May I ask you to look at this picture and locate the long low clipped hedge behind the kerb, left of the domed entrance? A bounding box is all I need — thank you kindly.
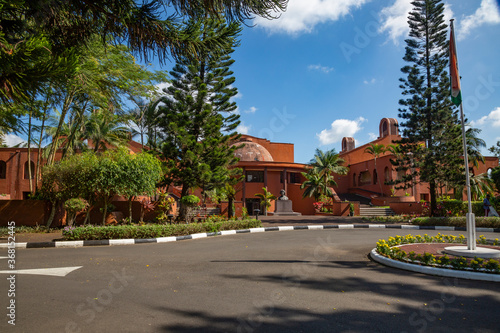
[63,219,262,240]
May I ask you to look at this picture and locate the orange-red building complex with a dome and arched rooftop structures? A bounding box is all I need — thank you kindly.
[0,118,498,215]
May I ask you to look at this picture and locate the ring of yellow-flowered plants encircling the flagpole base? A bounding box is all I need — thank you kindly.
[376,234,500,274]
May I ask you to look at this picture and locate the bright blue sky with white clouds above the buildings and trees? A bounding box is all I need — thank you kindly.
[7,0,500,163]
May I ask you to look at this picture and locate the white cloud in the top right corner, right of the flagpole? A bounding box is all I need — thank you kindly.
[457,0,500,39]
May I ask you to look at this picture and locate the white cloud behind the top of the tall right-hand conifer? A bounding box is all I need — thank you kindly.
[379,0,453,45]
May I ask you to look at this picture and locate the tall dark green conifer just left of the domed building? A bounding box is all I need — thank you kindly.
[158,19,241,217]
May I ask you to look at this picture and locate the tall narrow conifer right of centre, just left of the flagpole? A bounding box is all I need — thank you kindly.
[398,0,463,214]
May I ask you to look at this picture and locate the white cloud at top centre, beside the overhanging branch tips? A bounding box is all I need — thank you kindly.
[255,0,369,35]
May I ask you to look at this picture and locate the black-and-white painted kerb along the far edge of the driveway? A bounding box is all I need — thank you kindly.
[0,224,500,249]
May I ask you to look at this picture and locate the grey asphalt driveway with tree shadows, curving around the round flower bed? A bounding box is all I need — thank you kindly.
[0,229,500,332]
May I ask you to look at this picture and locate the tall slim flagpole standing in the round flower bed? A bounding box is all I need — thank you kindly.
[450,19,476,251]
